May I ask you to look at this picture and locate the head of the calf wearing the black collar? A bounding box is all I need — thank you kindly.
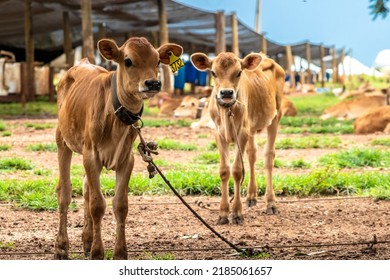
[98,37,183,98]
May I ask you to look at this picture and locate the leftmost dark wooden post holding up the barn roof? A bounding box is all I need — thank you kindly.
[22,0,35,102]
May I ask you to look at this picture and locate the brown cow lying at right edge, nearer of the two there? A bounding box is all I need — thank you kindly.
[354,106,390,134]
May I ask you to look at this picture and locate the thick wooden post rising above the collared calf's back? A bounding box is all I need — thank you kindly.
[81,0,95,64]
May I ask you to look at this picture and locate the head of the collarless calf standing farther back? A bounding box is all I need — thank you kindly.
[191,52,262,107]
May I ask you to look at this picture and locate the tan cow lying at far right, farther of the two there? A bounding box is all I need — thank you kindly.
[321,89,389,120]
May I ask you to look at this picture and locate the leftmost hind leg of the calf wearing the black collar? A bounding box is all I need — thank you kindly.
[54,129,72,260]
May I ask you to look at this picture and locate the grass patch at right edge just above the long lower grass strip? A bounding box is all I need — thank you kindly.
[319,148,390,168]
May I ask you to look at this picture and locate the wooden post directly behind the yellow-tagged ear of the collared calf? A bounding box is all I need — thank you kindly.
[157,0,173,93]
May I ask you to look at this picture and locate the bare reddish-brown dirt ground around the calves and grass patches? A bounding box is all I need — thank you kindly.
[0,119,390,260]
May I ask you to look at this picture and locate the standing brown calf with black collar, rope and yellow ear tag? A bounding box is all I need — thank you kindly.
[55,38,182,259]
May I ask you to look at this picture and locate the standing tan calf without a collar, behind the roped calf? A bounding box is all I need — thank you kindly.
[191,52,285,224]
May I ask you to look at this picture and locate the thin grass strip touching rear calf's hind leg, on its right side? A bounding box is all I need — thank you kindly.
[275,136,341,149]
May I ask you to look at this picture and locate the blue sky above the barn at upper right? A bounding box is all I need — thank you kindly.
[176,0,390,67]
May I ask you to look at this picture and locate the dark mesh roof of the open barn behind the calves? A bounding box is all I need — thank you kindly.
[0,0,336,62]
